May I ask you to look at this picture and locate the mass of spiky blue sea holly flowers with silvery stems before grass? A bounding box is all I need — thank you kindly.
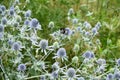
[0,0,120,80]
